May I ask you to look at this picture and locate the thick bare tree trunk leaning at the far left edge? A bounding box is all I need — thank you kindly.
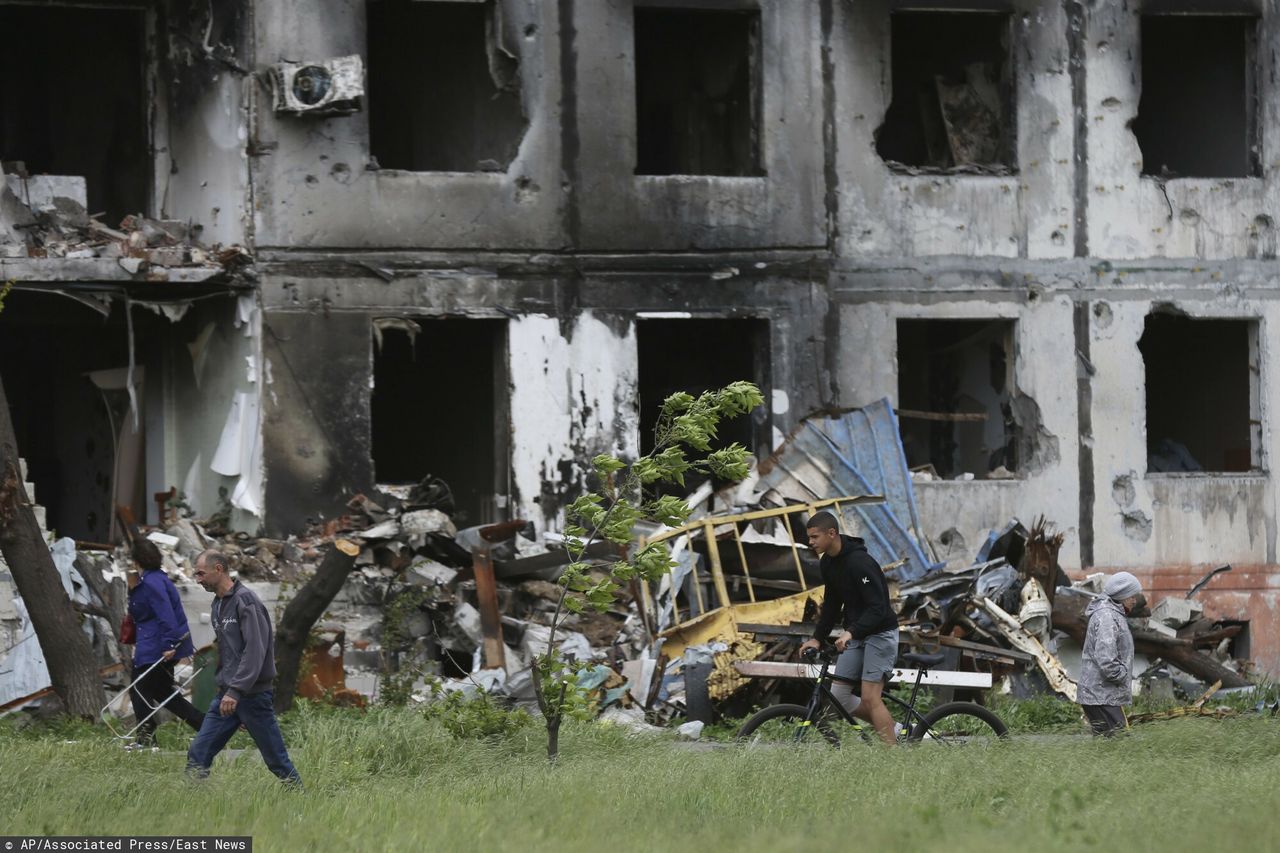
[0,382,106,720]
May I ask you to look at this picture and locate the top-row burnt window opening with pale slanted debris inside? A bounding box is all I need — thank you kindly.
[876,12,1016,173]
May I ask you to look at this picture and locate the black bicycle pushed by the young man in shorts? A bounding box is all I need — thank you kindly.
[737,644,1009,747]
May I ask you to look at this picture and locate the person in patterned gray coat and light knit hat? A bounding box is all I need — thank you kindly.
[1076,571,1142,738]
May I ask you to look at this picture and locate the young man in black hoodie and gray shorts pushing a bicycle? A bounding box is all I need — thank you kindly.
[800,510,897,744]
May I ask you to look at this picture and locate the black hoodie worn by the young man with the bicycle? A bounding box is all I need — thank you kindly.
[813,534,897,640]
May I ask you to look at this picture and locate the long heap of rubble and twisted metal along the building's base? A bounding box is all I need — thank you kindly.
[0,401,1251,727]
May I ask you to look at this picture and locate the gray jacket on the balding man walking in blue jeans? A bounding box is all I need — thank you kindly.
[212,580,275,699]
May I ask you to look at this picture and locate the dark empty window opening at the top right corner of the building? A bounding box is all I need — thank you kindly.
[1133,15,1262,178]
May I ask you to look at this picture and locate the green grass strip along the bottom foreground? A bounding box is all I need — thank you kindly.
[0,708,1280,853]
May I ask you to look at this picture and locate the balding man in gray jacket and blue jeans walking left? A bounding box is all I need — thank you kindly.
[187,551,302,786]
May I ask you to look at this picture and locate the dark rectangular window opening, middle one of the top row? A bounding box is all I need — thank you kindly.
[635,6,763,177]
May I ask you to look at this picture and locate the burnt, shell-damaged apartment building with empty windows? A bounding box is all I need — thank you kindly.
[0,0,1280,672]
